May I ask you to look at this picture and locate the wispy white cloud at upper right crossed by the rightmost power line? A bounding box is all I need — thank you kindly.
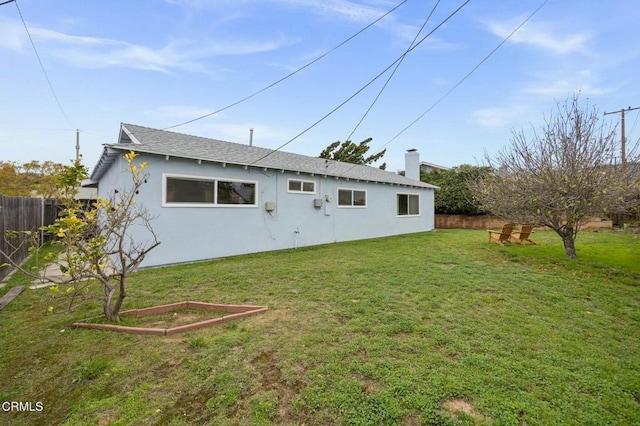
[485,17,590,55]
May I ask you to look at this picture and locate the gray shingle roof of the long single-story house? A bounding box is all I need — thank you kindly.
[91,123,437,189]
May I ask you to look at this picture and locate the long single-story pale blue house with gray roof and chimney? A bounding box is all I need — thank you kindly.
[91,124,437,267]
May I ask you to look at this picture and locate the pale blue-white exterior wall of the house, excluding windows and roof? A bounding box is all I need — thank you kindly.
[98,154,434,267]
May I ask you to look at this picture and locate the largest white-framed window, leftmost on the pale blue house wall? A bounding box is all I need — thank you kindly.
[164,176,257,206]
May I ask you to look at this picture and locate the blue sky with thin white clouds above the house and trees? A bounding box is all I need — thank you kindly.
[0,0,640,171]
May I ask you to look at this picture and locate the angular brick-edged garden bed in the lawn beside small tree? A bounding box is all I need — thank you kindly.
[72,302,268,336]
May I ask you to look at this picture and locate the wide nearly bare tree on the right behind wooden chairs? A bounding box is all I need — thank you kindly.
[470,95,639,258]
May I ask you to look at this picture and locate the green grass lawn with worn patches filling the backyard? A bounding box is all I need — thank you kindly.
[0,230,640,425]
